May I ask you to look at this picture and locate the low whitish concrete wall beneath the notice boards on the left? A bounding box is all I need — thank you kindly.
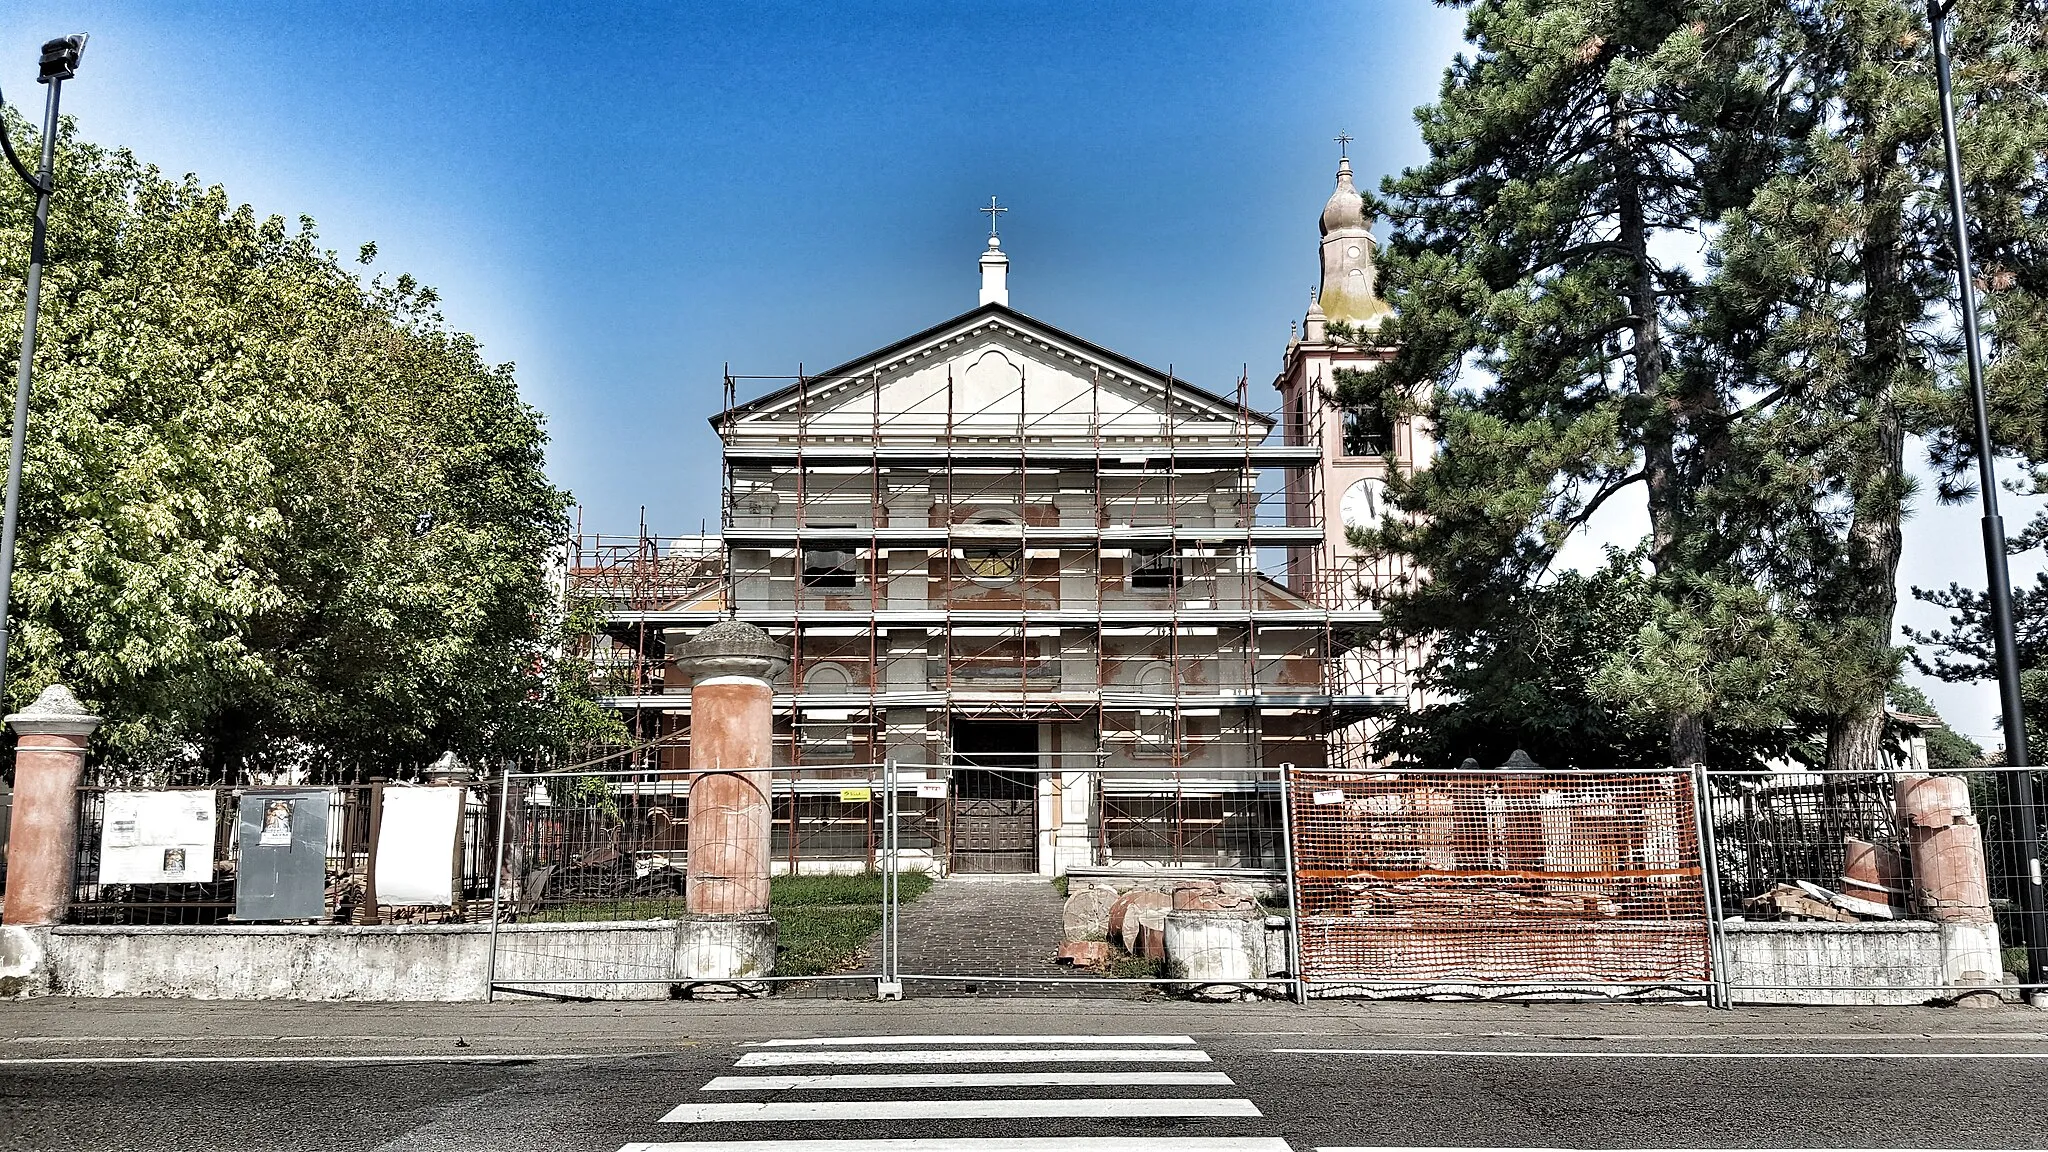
[0,918,774,1000]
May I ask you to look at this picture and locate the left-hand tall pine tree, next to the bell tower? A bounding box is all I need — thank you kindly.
[1339,0,1806,765]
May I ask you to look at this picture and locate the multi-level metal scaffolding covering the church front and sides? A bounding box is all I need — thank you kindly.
[567,309,1411,865]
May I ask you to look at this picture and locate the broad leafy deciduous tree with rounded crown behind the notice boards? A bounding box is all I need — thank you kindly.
[0,121,606,775]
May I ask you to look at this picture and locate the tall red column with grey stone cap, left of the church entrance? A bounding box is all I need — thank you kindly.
[676,619,788,916]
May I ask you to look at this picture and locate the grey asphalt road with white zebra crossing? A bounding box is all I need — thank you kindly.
[0,1000,2048,1152]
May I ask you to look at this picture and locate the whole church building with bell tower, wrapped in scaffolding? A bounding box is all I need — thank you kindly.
[571,150,1427,875]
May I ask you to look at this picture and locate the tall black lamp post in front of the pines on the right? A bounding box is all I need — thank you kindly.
[1927,0,2048,984]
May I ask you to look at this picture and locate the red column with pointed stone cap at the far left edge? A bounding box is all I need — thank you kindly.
[0,685,100,927]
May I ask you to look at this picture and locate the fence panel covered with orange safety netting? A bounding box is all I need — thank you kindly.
[1286,769,1718,1000]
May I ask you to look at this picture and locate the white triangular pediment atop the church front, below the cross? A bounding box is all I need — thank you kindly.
[713,303,1272,441]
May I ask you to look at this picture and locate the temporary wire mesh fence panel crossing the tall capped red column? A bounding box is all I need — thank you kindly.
[485,765,897,998]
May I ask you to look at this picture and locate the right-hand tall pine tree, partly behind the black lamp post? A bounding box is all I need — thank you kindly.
[1716,0,2048,769]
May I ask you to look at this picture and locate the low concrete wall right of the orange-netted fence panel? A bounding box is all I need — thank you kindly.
[1724,920,2003,1004]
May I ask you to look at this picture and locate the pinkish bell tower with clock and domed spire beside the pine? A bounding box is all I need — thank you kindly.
[1274,135,1432,609]
